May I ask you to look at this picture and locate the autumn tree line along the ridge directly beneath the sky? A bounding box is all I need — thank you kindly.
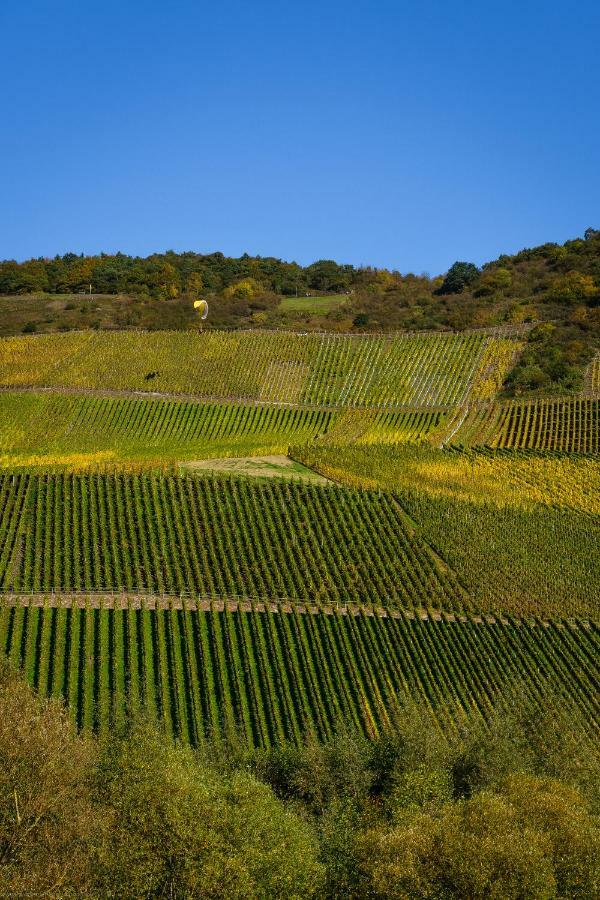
[0,228,600,303]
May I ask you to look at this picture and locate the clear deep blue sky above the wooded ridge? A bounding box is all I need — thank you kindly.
[0,0,600,274]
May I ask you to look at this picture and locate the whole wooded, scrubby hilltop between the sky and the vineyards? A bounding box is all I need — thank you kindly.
[0,229,600,396]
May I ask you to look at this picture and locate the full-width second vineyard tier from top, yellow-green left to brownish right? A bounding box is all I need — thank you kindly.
[0,391,600,468]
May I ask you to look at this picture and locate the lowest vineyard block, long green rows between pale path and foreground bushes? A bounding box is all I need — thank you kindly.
[0,606,600,747]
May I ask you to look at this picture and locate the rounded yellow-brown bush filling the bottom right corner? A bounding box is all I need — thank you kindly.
[355,775,600,900]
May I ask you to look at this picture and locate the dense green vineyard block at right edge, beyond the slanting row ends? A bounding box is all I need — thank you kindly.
[399,491,600,619]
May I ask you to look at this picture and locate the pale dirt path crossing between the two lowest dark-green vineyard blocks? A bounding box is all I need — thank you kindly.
[0,591,590,629]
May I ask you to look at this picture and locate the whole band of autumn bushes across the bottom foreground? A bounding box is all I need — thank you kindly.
[0,670,600,900]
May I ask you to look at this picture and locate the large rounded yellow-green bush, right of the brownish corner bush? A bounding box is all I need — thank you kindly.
[91,726,321,898]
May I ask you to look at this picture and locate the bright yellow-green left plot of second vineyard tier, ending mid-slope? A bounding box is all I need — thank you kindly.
[0,392,334,468]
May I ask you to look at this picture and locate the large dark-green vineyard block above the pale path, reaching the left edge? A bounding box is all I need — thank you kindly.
[0,473,468,609]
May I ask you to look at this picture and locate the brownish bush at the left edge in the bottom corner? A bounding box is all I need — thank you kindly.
[0,664,106,897]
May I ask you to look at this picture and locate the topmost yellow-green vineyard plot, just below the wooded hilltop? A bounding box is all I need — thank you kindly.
[0,331,519,408]
